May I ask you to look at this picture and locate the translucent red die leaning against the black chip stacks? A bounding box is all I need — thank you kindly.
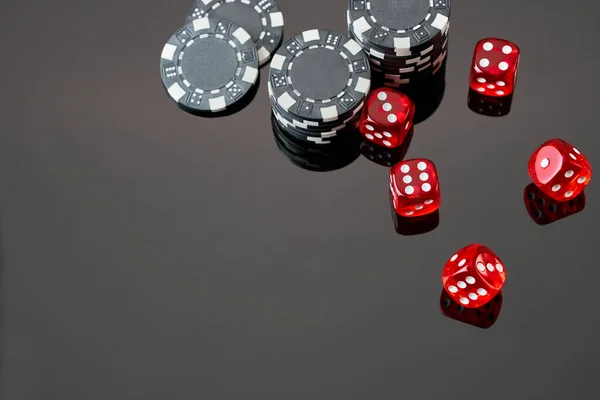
[358,88,415,148]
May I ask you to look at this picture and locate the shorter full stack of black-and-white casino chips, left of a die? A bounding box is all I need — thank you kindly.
[268,29,371,145]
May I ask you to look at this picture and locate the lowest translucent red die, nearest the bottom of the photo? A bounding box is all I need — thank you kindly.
[442,244,506,308]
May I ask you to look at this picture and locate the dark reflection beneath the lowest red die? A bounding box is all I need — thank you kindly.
[440,290,502,329]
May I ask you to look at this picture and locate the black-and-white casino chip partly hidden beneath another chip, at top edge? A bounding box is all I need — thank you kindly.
[186,0,283,65]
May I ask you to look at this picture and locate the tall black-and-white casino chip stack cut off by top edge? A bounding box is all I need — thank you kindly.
[347,0,451,87]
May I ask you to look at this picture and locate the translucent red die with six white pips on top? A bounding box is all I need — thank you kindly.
[390,158,441,218]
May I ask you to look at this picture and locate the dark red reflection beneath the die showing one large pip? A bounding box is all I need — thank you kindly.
[523,183,585,225]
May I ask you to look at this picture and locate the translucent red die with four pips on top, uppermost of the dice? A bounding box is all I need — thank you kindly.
[469,38,521,97]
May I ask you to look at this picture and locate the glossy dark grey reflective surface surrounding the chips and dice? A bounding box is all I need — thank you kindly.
[0,0,600,400]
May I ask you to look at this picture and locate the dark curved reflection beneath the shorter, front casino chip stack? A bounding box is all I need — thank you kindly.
[271,115,360,172]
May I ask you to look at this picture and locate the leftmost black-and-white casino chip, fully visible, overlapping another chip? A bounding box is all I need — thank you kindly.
[160,18,258,115]
